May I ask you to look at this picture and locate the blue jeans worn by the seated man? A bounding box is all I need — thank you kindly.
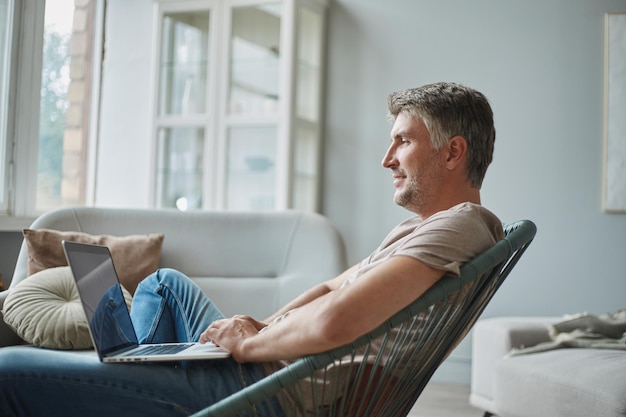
[0,269,280,417]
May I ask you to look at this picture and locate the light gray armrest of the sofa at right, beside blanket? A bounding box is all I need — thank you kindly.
[470,317,560,413]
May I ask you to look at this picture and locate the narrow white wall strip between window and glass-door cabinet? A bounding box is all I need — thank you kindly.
[95,0,154,207]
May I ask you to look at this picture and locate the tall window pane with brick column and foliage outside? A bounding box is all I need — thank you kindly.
[36,0,94,212]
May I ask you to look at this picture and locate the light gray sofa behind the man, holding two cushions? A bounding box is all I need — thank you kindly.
[0,207,346,346]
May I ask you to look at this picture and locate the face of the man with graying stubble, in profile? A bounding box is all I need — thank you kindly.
[382,113,444,214]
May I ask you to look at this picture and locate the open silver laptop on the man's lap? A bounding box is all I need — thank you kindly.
[62,240,230,362]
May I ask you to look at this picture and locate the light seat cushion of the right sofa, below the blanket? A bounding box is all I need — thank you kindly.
[494,349,626,417]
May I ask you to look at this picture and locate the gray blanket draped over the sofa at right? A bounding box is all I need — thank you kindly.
[511,309,626,355]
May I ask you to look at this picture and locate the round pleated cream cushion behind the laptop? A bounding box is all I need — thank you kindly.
[3,266,132,349]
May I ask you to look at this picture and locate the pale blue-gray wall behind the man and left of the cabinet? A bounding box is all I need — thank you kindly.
[97,0,626,382]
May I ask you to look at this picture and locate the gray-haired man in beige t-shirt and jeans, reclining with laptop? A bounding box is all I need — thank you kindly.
[0,83,503,417]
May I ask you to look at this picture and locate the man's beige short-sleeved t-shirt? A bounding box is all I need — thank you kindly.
[263,203,504,415]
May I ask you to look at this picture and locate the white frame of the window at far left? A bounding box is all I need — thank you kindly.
[0,0,106,230]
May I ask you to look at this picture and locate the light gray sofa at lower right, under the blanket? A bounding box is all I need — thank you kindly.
[470,317,626,417]
